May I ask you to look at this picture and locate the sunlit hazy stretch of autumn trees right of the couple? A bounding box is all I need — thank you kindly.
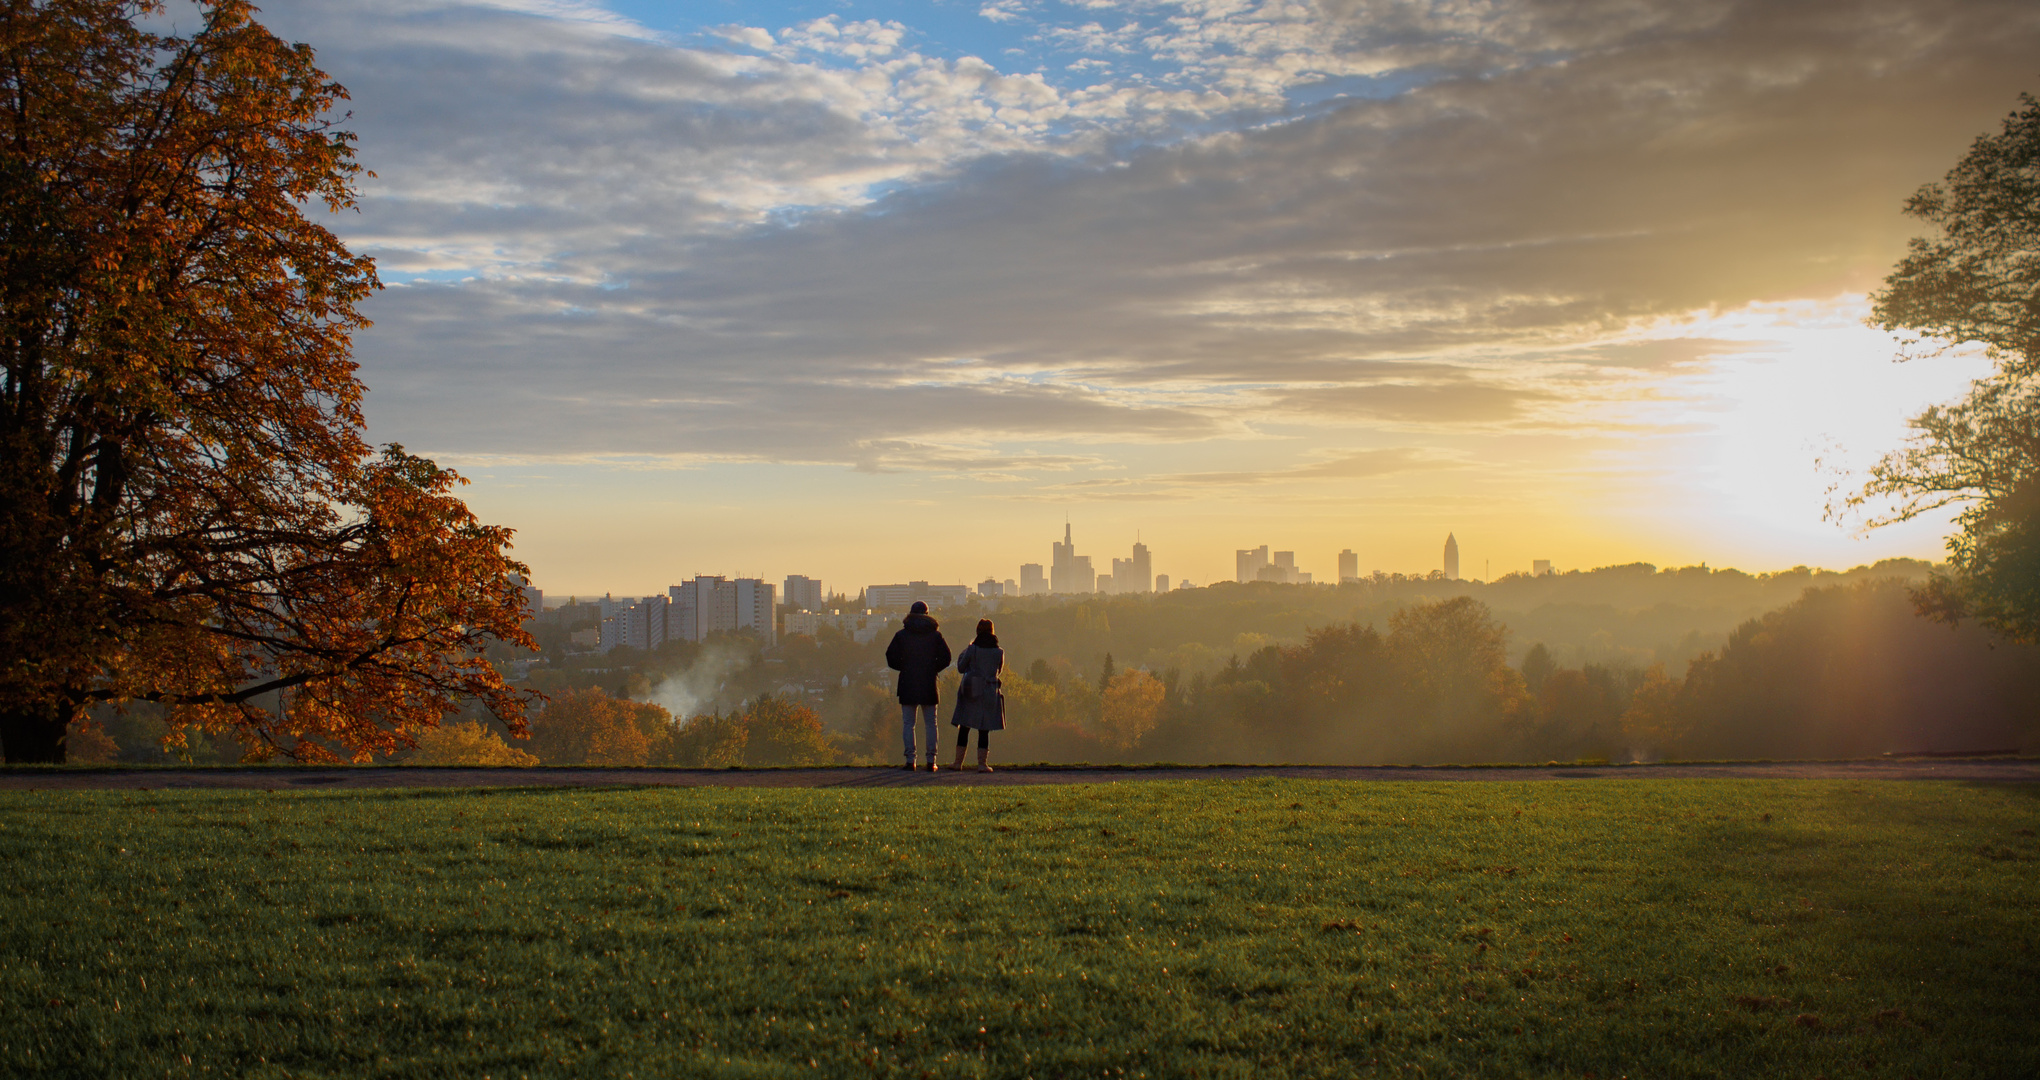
[979,580,2040,764]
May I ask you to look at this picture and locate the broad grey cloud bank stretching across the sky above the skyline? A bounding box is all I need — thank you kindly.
[246,0,2040,484]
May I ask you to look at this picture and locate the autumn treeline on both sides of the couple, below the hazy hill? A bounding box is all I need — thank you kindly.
[88,576,2040,768]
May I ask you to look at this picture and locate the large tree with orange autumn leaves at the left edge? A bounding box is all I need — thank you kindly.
[0,0,532,762]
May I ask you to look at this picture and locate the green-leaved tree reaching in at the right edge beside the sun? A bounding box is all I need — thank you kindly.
[1848,94,2040,643]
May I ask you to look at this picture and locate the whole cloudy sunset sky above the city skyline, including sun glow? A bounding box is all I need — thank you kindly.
[215,0,2040,596]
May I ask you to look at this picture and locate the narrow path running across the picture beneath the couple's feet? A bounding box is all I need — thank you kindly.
[0,757,2040,790]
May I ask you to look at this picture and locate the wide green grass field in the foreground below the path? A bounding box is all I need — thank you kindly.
[0,778,2040,1080]
